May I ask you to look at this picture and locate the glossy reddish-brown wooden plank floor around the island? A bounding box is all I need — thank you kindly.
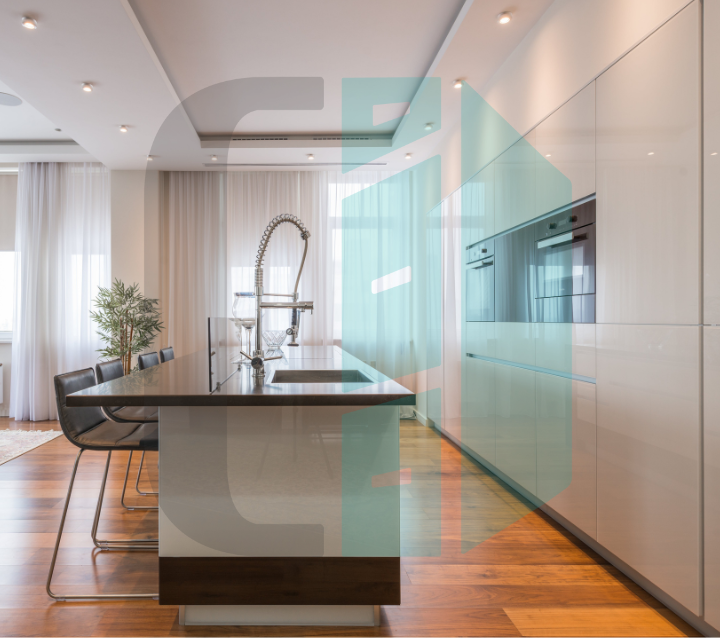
[0,419,700,636]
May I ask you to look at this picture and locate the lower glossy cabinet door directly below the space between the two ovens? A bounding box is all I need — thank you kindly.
[495,364,537,494]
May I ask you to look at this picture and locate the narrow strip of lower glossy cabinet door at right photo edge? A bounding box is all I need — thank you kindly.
[703,327,720,627]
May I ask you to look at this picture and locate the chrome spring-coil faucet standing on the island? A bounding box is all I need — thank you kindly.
[250,215,313,377]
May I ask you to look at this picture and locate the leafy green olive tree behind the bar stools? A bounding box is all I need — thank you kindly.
[90,279,164,374]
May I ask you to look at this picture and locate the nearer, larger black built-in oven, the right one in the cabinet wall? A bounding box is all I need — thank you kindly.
[535,199,595,323]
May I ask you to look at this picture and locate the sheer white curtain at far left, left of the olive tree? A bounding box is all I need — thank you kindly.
[10,163,110,421]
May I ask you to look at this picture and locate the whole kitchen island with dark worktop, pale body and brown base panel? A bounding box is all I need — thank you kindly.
[67,346,415,625]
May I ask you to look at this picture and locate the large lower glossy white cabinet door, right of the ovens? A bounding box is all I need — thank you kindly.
[597,325,701,614]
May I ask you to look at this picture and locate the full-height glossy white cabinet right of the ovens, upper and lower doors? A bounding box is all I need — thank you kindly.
[596,2,701,614]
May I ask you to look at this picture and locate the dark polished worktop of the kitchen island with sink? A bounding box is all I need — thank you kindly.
[67,346,415,407]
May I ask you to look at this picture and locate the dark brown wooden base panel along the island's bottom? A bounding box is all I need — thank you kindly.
[159,556,400,606]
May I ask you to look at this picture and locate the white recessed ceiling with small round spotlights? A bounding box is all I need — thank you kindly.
[0,0,552,170]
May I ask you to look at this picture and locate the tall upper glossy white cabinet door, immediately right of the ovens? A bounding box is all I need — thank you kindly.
[596,2,700,325]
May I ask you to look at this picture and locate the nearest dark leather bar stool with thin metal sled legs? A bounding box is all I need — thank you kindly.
[45,368,159,600]
